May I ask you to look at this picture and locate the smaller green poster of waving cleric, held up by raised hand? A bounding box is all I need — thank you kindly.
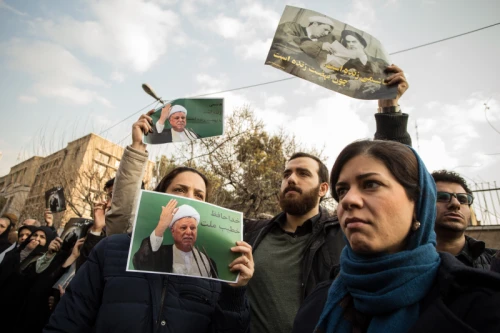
[144,98,224,144]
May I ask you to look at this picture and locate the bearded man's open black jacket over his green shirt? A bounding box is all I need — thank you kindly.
[244,208,345,299]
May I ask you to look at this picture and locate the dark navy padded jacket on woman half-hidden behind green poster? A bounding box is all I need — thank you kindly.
[44,234,250,333]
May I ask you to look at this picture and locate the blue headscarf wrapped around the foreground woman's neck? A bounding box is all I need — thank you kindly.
[315,147,441,333]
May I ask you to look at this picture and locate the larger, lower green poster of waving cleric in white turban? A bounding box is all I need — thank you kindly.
[127,190,243,282]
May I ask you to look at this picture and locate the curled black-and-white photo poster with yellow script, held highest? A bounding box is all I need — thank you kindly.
[265,6,397,99]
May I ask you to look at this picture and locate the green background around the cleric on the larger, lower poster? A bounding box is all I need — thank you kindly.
[127,190,243,282]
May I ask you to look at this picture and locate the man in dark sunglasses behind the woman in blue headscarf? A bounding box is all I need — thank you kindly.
[432,170,497,270]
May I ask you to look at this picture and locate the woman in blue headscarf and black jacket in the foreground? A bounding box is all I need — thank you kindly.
[293,140,500,333]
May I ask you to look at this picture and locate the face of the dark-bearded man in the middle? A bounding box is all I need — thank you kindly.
[280,157,328,216]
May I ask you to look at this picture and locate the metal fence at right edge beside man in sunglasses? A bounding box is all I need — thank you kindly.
[472,181,500,225]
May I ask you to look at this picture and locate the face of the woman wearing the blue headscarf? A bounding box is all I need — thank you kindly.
[335,155,415,254]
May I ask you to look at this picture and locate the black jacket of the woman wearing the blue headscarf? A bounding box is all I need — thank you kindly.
[292,253,500,333]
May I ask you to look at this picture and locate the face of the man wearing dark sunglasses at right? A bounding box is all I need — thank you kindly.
[435,182,471,232]
